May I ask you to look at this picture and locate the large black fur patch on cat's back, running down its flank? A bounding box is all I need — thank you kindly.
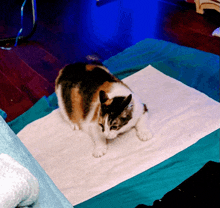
[57,63,118,118]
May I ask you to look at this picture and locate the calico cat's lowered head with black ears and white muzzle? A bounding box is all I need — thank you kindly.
[98,90,133,139]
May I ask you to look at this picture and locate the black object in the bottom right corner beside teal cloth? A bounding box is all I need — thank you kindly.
[136,161,220,208]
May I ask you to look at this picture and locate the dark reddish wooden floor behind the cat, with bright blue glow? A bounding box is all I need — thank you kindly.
[0,0,220,122]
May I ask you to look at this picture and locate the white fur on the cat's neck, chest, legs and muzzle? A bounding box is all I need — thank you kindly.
[56,83,152,157]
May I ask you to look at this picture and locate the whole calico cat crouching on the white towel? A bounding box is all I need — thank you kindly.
[55,63,152,157]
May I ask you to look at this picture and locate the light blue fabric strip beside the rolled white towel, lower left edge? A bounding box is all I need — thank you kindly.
[0,116,72,208]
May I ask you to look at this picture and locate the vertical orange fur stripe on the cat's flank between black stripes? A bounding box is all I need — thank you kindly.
[71,88,83,125]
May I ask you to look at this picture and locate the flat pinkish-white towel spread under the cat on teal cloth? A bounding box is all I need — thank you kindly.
[18,66,220,205]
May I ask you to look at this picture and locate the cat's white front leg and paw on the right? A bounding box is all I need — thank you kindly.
[135,113,153,141]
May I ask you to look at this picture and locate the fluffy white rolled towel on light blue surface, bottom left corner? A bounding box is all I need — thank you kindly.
[0,154,39,208]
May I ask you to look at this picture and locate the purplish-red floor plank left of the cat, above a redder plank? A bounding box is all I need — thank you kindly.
[0,50,54,103]
